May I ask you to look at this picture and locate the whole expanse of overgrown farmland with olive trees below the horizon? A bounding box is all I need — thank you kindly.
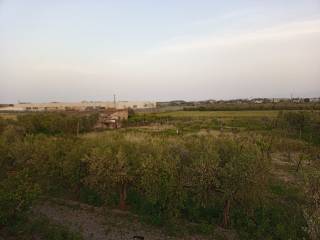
[0,111,320,240]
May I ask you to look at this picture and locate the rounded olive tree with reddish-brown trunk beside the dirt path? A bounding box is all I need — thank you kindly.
[84,135,138,209]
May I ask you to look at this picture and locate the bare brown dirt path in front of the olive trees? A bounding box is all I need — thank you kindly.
[33,201,221,240]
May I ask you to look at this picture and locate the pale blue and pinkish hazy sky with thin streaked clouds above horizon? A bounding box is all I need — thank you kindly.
[0,0,320,103]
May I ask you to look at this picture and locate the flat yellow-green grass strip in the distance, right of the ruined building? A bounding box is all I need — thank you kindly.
[129,111,278,132]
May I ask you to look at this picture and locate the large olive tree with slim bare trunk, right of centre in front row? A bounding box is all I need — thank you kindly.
[217,139,269,227]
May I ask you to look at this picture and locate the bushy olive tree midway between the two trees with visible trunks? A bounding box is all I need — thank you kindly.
[138,139,187,219]
